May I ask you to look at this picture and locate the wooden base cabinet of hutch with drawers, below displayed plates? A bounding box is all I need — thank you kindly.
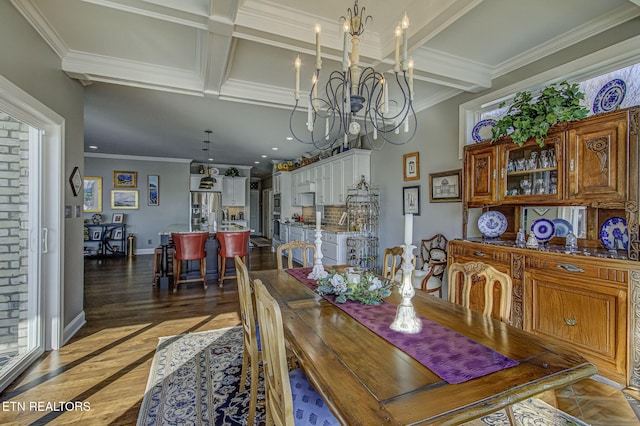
[448,240,640,385]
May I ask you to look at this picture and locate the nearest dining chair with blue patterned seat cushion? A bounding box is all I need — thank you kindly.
[253,279,340,425]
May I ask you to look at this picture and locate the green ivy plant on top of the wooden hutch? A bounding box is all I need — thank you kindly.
[492,81,589,146]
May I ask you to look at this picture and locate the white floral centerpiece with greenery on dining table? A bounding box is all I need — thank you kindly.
[316,270,393,305]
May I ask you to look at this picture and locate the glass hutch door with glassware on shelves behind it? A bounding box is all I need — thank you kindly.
[501,135,563,201]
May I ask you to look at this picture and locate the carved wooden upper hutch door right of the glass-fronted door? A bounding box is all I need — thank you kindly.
[567,111,637,202]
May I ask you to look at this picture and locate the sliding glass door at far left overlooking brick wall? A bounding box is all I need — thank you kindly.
[0,111,46,388]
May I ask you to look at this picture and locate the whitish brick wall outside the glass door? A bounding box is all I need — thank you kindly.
[0,112,29,366]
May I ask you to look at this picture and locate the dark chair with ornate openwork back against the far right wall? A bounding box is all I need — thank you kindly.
[413,234,449,297]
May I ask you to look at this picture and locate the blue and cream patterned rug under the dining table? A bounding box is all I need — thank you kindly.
[137,327,587,426]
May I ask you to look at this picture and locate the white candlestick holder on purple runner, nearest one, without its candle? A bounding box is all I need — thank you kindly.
[390,244,422,334]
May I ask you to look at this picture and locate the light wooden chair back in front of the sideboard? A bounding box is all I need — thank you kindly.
[447,262,513,323]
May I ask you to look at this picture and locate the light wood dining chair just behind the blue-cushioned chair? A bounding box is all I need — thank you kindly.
[234,256,261,425]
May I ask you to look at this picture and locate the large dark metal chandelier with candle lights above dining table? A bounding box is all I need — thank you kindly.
[289,0,417,149]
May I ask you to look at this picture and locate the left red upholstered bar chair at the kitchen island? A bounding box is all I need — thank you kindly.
[171,232,209,293]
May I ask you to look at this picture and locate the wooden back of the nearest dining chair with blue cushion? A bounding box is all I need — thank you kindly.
[254,280,294,425]
